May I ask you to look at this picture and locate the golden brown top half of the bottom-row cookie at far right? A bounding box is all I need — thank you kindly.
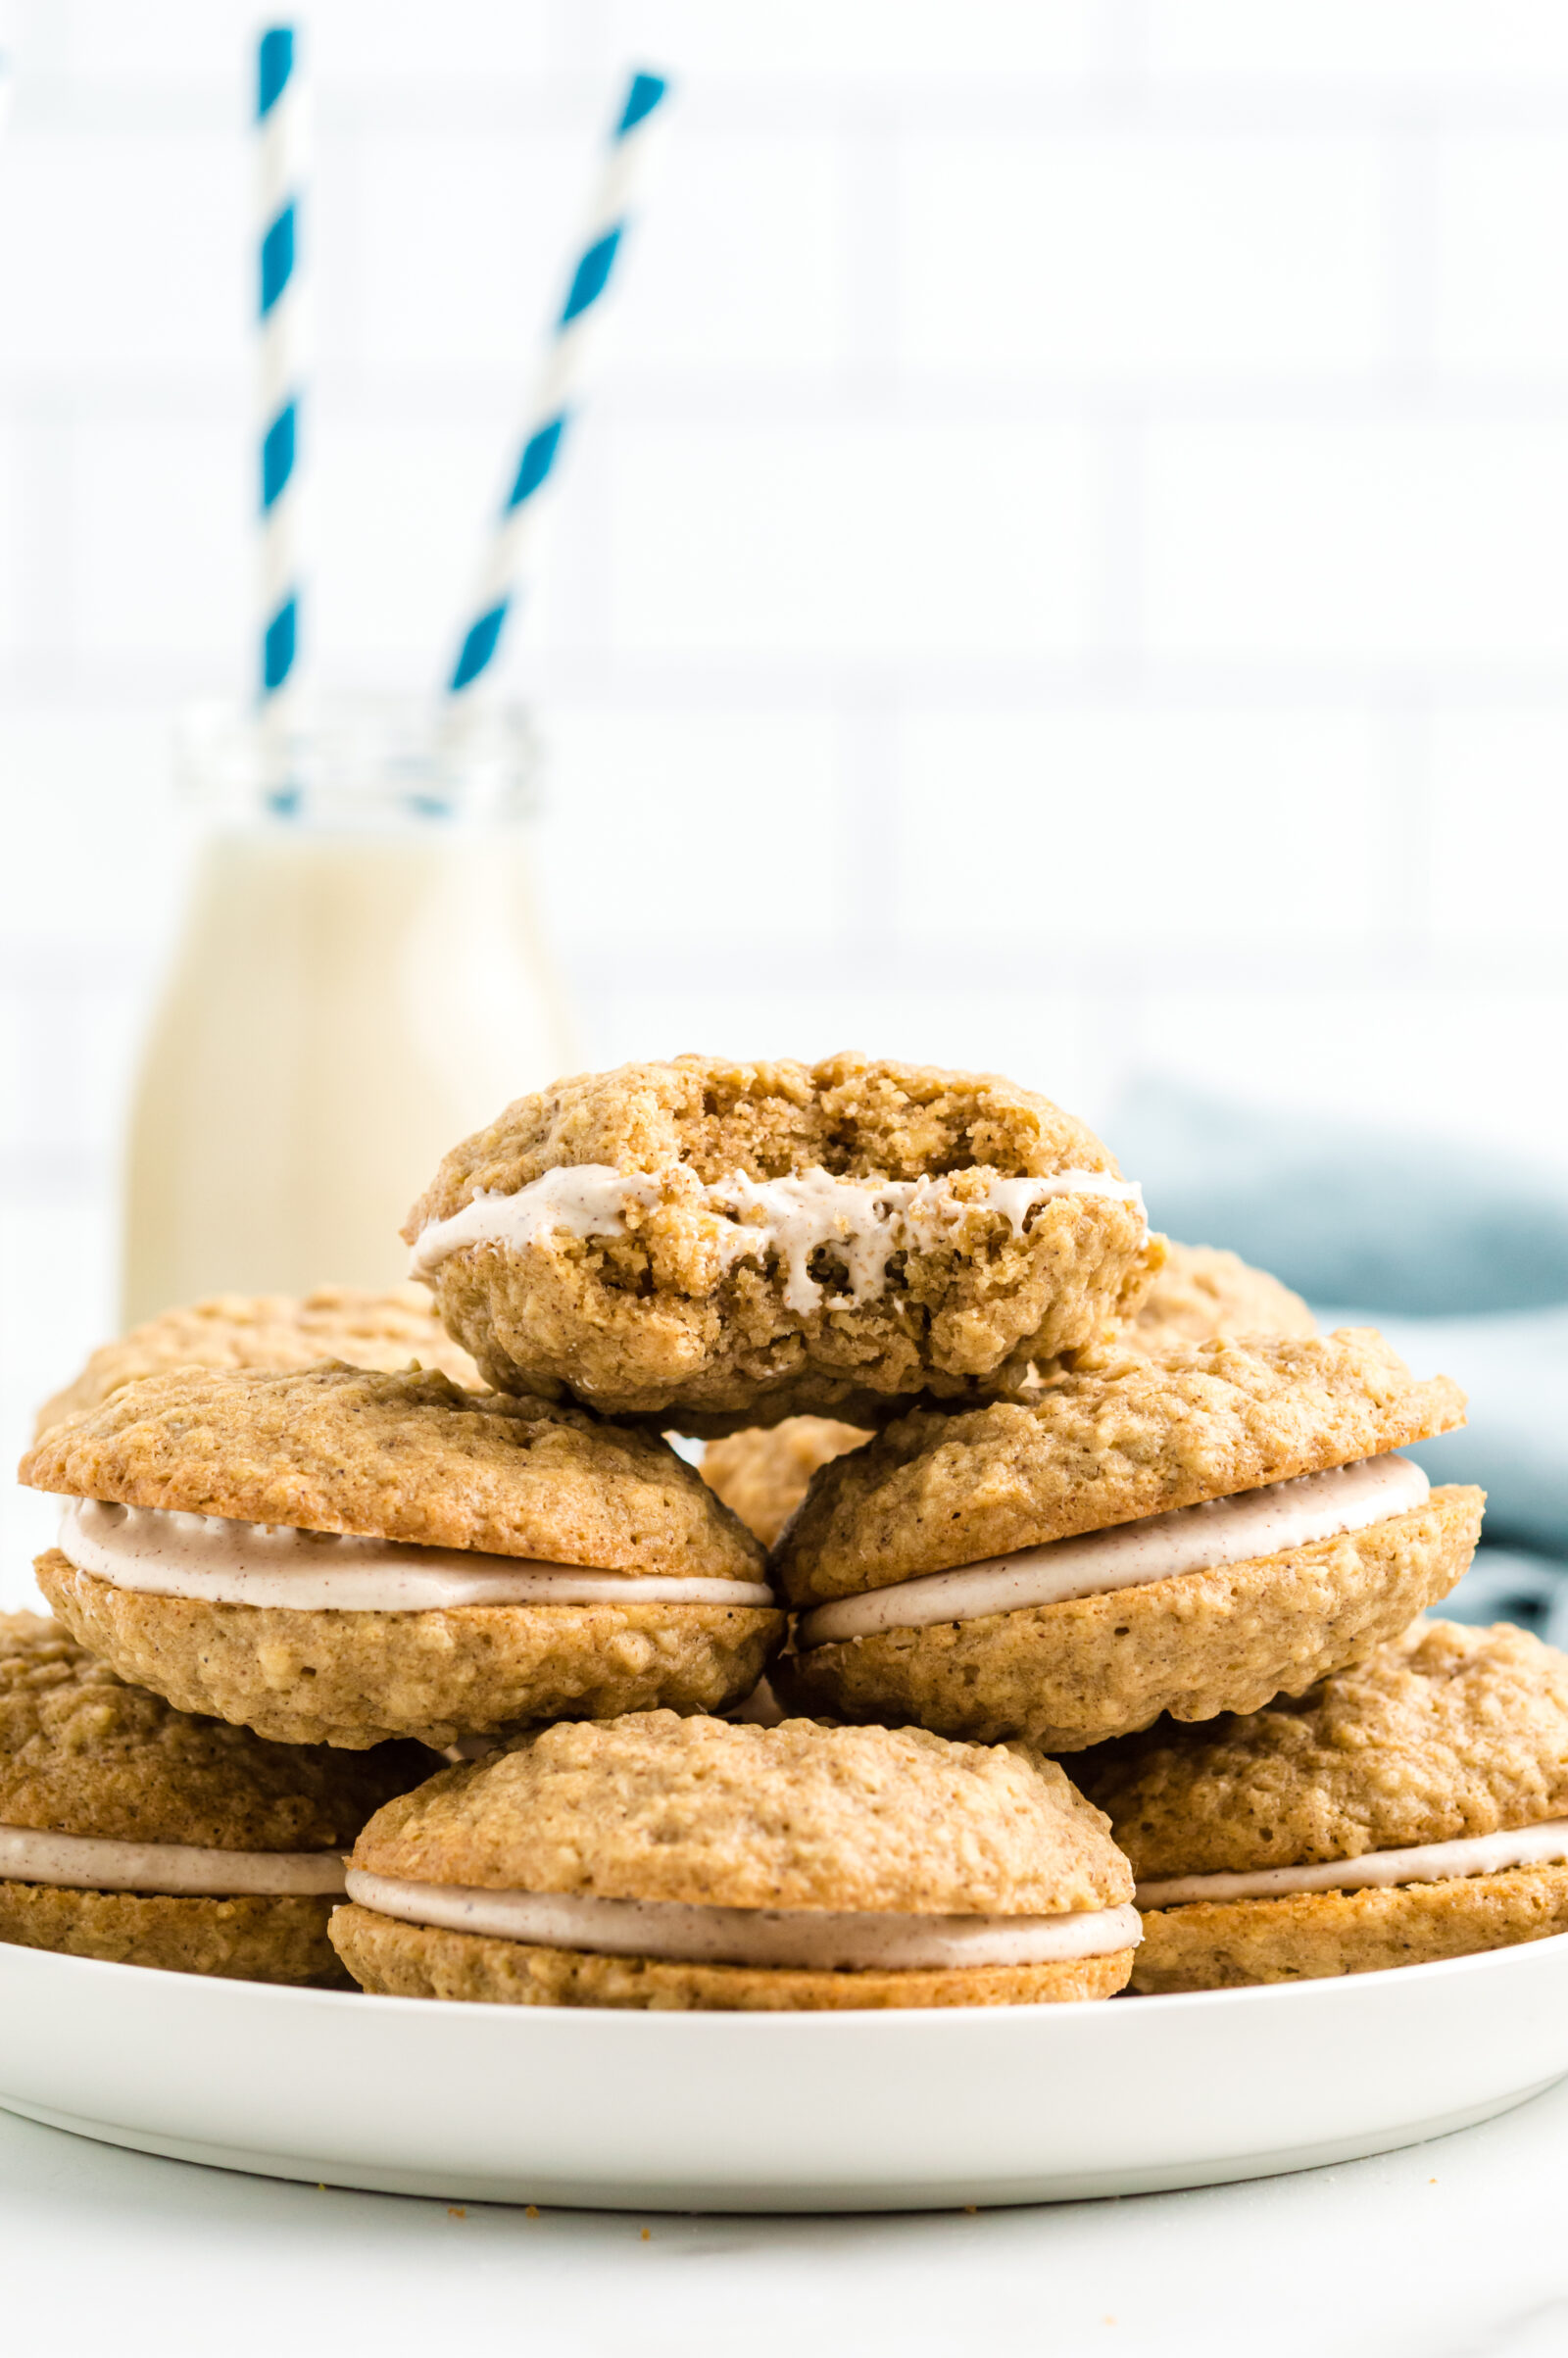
[1075,1620,1568,1880]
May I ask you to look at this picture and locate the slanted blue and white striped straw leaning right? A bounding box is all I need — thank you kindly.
[448,74,669,696]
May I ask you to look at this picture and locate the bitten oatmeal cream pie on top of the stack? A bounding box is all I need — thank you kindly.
[403,1056,1160,1436]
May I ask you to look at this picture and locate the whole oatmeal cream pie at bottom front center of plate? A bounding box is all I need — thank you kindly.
[332,1712,1139,2011]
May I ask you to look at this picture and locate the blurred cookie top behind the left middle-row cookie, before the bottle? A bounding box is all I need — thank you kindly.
[35,1285,478,1434]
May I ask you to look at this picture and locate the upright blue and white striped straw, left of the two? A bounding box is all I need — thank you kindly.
[257,25,304,710]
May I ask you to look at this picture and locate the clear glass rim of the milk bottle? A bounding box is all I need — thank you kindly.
[174,696,540,825]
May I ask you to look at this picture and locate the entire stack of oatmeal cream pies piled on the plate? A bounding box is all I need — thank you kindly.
[15,1056,1568,2009]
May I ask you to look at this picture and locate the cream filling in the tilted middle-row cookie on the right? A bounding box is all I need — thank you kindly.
[797,1455,1431,1646]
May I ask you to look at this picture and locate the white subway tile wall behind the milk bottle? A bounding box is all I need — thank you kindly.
[0,0,1568,1584]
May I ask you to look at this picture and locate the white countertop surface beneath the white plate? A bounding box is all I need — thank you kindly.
[0,2082,1568,2358]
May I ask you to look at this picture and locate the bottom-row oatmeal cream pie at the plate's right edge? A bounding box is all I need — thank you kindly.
[1080,1620,1568,1992]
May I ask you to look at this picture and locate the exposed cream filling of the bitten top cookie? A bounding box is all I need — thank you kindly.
[411,1162,1149,1311]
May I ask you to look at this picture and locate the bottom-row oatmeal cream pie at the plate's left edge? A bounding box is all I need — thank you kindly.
[0,1613,431,1988]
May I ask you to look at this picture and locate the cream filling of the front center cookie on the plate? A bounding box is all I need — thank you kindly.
[349,1868,1144,1974]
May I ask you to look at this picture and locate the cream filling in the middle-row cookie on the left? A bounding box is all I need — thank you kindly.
[59,1498,778,1613]
